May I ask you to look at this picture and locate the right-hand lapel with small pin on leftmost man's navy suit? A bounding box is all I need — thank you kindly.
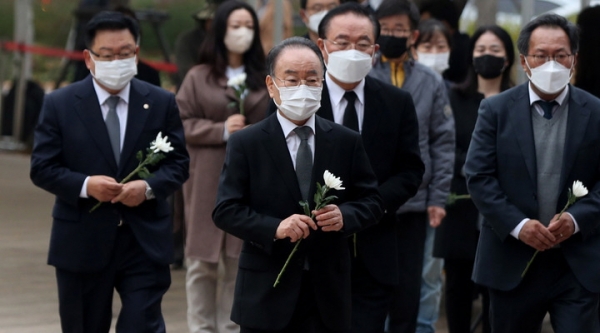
[119,79,149,174]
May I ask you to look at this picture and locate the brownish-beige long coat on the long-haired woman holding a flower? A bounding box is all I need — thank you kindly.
[177,65,269,263]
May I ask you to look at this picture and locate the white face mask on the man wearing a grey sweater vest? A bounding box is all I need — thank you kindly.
[525,58,573,95]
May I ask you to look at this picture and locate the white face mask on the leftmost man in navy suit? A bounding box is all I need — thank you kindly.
[90,56,137,90]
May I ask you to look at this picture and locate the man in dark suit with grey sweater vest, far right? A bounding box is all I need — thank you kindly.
[465,14,600,333]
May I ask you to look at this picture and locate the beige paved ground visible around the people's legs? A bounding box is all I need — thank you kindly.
[0,151,552,333]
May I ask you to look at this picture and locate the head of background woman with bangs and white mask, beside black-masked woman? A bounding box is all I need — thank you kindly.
[412,19,452,88]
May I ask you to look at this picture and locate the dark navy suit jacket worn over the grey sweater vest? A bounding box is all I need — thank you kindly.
[465,83,600,293]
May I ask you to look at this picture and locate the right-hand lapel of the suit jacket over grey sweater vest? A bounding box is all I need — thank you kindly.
[560,86,590,189]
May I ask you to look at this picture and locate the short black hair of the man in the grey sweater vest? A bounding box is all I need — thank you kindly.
[517,14,579,55]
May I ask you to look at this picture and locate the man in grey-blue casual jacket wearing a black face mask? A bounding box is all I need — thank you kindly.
[369,0,454,333]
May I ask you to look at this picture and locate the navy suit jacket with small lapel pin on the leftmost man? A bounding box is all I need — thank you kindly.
[31,76,189,272]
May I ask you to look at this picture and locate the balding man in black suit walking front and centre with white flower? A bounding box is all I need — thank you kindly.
[213,37,383,333]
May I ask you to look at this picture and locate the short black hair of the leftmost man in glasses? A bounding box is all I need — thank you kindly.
[84,11,140,49]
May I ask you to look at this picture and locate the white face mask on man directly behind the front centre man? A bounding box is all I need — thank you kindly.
[325,47,373,83]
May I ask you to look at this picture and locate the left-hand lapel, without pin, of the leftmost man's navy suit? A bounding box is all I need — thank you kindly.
[75,75,117,173]
